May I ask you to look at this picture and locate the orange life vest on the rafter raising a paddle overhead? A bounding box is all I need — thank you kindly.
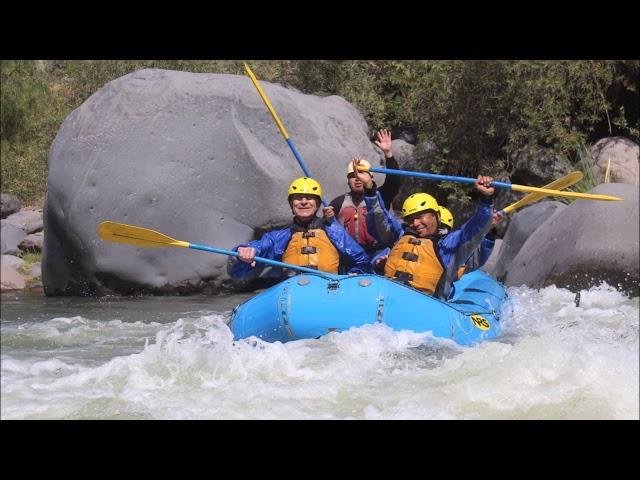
[384,235,444,295]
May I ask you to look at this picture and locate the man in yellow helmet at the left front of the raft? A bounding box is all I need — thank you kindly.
[227,177,370,278]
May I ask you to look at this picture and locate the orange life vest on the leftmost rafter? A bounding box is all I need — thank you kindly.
[282,228,340,273]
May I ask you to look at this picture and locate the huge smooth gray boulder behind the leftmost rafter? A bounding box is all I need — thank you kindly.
[42,69,384,295]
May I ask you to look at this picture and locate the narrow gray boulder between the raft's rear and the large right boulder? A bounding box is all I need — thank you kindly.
[486,200,566,281]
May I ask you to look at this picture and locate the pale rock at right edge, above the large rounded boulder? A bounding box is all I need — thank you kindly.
[591,137,640,185]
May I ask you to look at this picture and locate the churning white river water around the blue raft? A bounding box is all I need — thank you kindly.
[0,285,640,419]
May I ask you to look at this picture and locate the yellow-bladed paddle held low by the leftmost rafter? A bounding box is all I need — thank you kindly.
[98,222,339,279]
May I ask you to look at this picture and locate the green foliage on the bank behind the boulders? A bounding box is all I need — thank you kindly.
[0,60,640,206]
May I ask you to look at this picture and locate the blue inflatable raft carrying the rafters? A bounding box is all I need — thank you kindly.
[229,270,507,345]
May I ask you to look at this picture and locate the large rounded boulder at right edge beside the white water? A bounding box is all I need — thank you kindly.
[505,183,640,296]
